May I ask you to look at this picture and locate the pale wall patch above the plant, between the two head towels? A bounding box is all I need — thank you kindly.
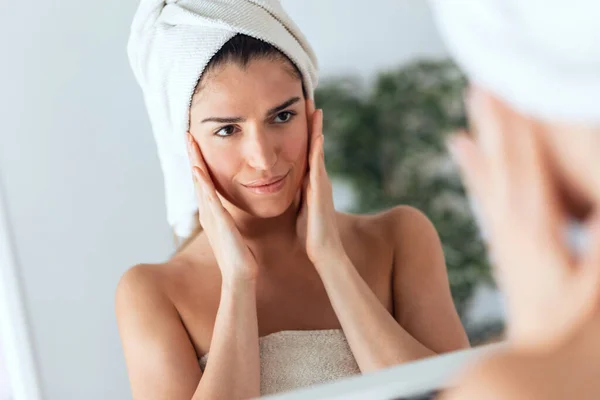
[282,0,447,78]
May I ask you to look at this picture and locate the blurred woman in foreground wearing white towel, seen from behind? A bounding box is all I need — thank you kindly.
[432,0,600,399]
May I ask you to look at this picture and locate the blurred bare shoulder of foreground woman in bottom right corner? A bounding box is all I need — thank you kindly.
[443,318,600,400]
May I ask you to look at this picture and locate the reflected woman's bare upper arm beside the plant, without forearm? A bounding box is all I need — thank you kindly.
[392,207,470,353]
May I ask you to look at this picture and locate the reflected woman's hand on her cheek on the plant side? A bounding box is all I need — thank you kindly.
[296,100,345,268]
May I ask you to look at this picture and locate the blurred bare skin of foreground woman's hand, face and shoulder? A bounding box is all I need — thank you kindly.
[443,88,600,400]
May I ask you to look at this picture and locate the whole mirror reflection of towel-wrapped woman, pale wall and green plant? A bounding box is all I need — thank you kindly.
[0,0,516,399]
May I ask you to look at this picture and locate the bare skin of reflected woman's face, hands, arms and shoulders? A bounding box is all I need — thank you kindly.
[116,59,468,399]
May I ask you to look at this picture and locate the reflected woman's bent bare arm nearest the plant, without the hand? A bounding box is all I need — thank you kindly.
[316,208,469,372]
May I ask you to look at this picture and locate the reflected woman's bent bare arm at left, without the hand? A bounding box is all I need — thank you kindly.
[116,266,260,400]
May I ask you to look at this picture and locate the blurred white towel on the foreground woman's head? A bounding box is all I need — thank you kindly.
[431,0,600,123]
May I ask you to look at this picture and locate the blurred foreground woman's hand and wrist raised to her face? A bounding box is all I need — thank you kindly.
[449,88,600,347]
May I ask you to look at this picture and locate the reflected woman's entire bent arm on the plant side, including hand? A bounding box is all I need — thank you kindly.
[297,103,468,372]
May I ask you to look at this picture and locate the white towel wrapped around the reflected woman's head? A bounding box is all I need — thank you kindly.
[127,0,317,237]
